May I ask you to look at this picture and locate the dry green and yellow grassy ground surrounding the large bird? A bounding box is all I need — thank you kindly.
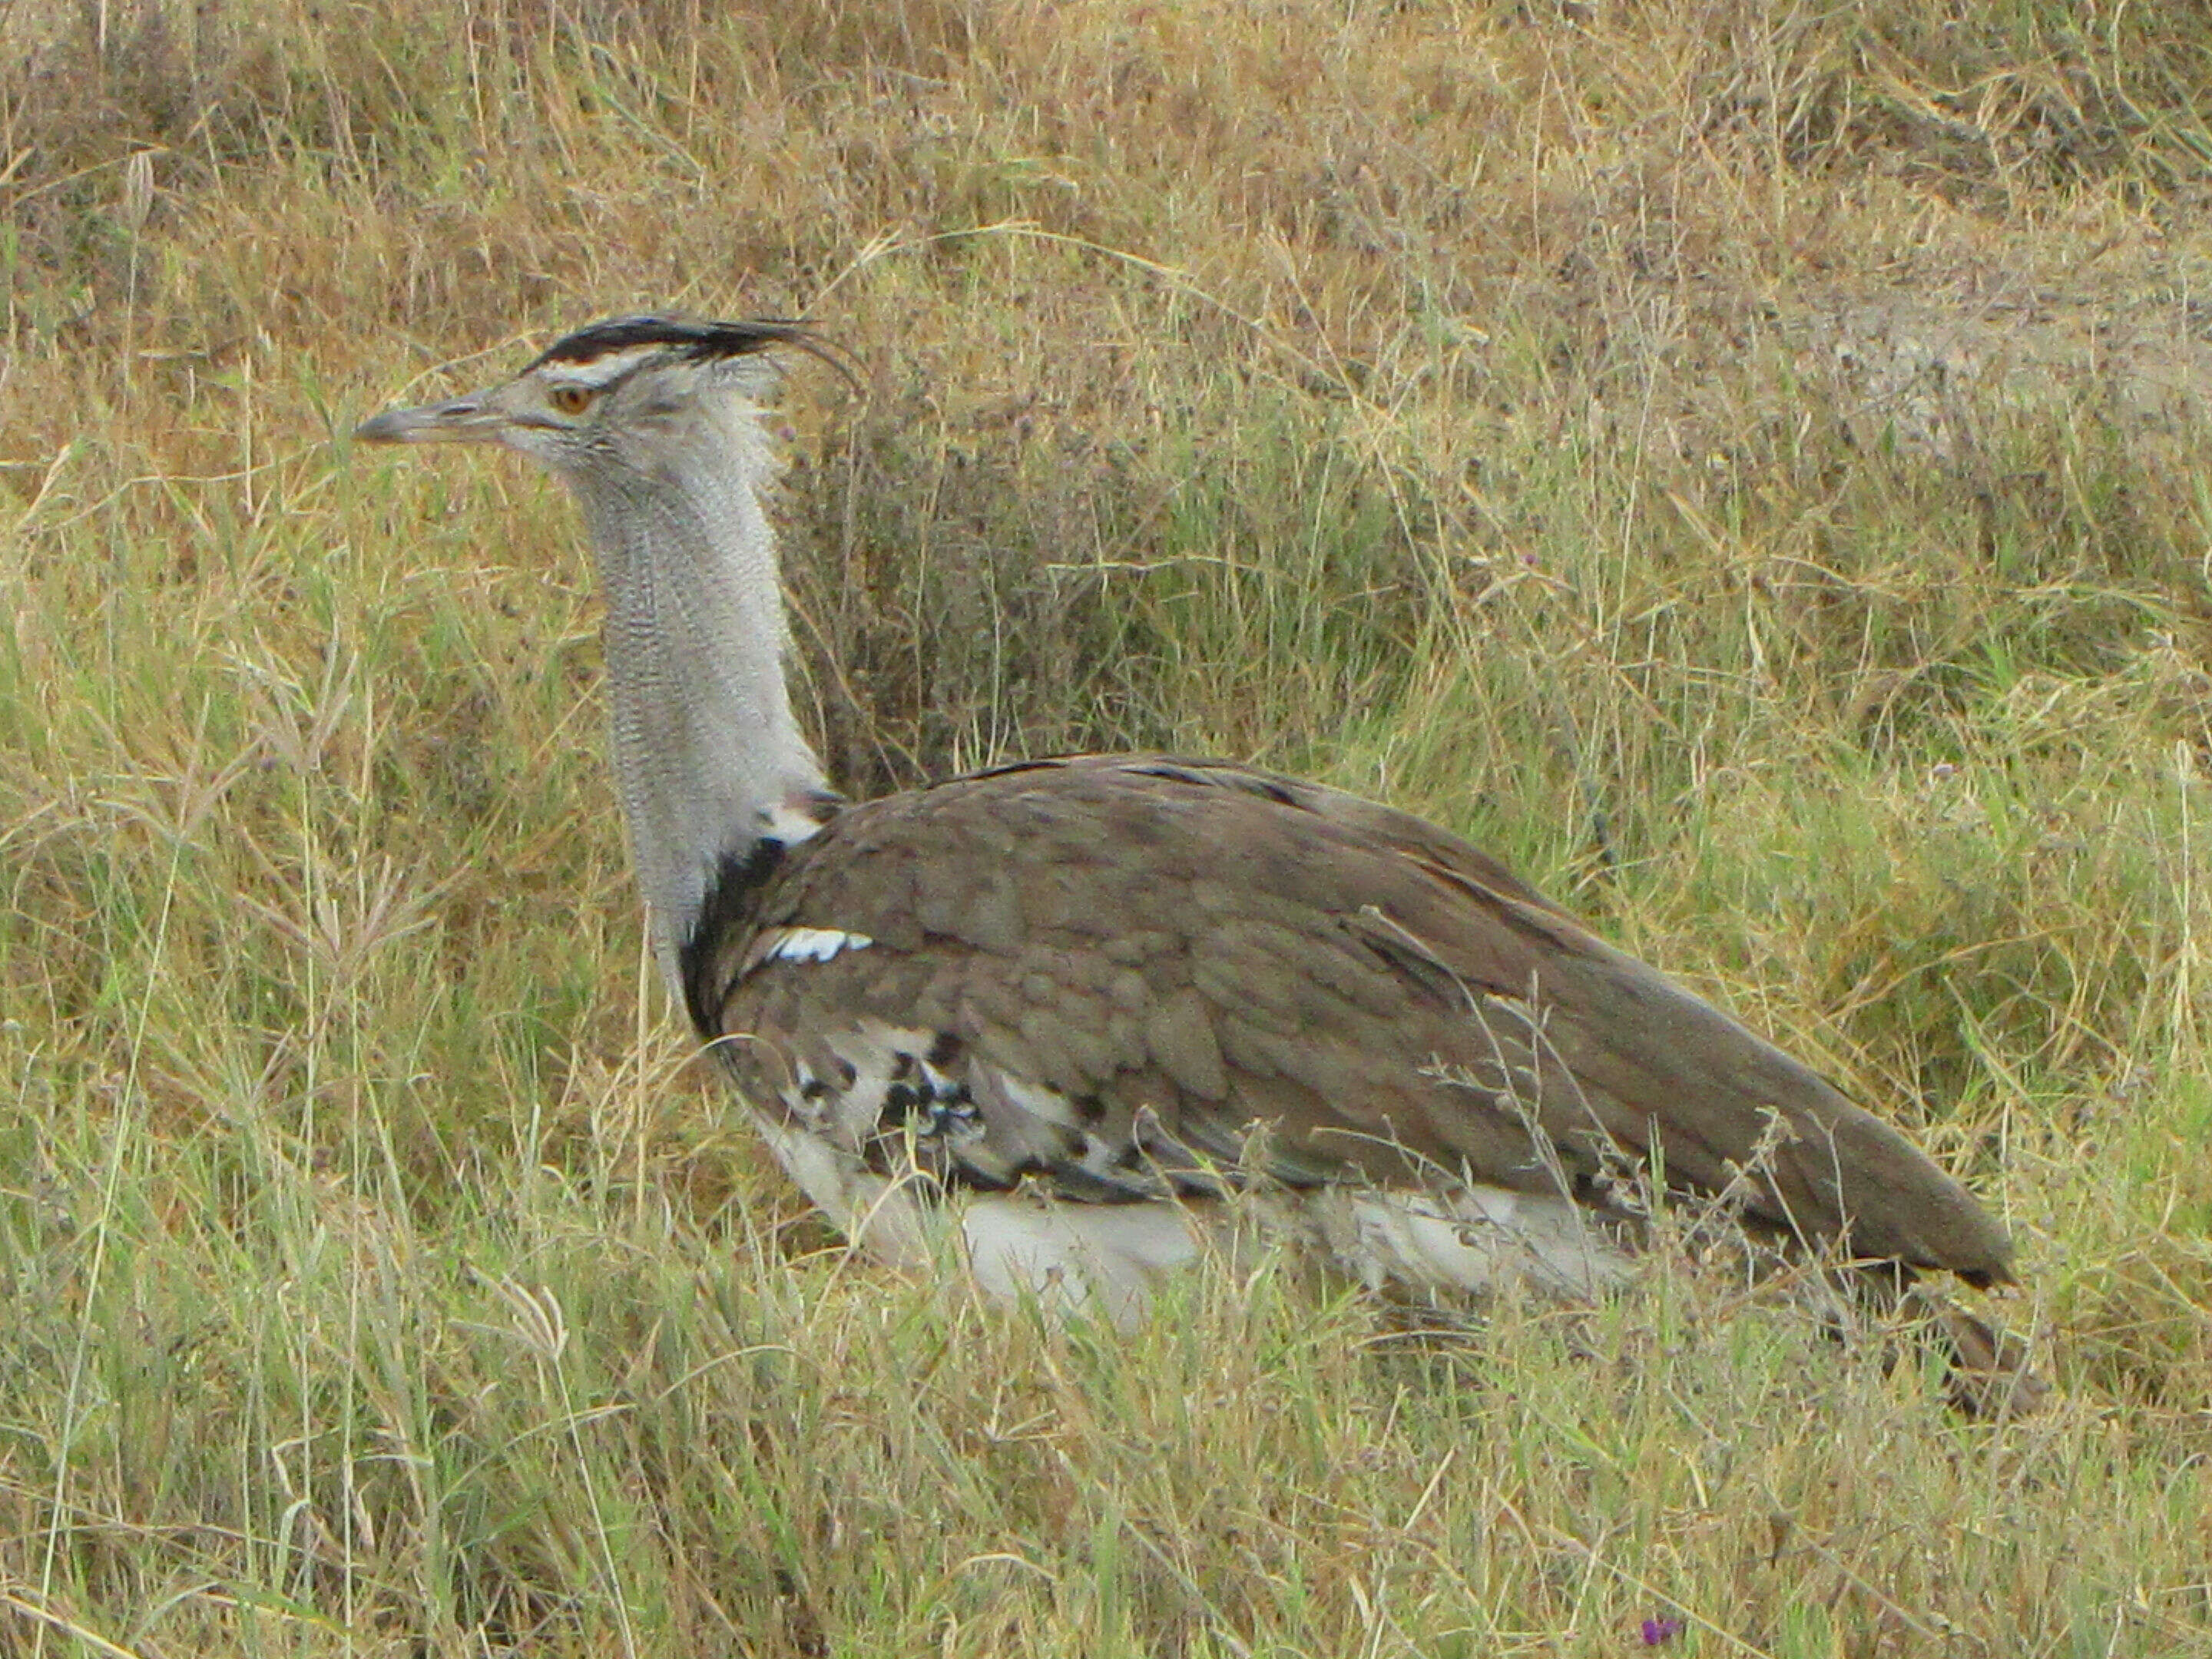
[0,0,2212,1659]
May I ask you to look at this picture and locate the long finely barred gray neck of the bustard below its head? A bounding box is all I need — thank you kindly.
[568,431,827,998]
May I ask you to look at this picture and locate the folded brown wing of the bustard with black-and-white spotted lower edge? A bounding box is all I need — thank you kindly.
[699,757,2011,1283]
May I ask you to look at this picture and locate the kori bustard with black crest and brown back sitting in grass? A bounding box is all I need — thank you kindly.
[359,316,2011,1406]
